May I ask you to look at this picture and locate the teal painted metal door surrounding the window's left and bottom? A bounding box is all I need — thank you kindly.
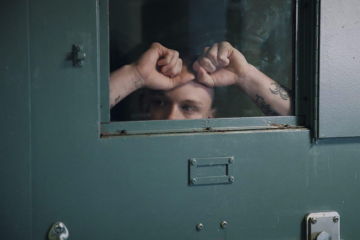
[0,0,360,240]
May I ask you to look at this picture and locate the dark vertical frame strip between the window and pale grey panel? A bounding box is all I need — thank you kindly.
[295,0,320,140]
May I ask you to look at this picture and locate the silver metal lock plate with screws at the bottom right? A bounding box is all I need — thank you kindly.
[306,212,340,240]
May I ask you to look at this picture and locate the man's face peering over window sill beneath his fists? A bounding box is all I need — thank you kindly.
[150,81,215,120]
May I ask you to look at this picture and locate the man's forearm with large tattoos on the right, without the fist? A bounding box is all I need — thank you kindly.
[238,65,291,116]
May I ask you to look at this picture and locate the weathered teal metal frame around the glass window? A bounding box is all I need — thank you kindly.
[98,0,318,136]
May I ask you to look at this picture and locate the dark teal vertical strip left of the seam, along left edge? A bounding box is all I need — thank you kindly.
[0,0,31,239]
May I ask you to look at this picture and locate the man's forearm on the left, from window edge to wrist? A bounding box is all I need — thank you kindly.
[109,65,142,108]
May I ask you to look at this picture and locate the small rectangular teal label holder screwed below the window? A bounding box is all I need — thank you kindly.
[189,157,235,185]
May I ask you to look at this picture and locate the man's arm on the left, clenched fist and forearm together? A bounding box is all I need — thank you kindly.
[109,43,195,108]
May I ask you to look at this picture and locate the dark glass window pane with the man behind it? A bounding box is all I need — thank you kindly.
[109,0,294,121]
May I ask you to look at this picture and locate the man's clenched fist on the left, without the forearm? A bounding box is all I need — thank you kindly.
[131,43,195,90]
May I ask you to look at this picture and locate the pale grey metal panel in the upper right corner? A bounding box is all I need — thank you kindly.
[319,0,360,138]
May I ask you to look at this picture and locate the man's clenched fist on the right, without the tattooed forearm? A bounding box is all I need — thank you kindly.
[193,42,251,87]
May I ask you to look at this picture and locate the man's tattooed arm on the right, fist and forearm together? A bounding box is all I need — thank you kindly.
[193,42,291,116]
